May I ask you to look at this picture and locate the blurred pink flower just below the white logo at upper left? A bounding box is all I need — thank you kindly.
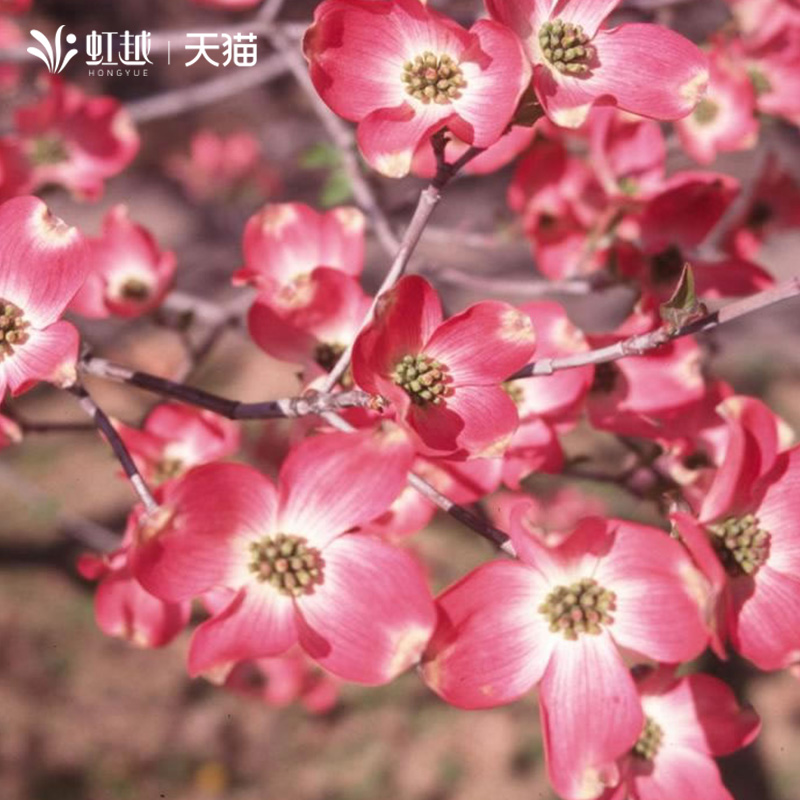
[15,75,139,200]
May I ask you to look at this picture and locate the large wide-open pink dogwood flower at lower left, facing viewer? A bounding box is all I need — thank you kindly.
[134,427,435,684]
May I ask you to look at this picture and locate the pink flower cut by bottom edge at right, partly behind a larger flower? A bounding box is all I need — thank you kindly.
[601,666,761,800]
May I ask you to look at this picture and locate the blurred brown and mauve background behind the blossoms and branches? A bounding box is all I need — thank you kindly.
[0,0,800,800]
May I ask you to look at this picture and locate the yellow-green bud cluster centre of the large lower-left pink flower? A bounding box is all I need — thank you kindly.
[250,533,324,597]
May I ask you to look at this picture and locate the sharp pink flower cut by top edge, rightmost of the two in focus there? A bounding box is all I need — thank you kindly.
[486,0,708,128]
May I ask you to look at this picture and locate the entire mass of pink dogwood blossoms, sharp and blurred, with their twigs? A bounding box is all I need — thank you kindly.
[0,0,800,800]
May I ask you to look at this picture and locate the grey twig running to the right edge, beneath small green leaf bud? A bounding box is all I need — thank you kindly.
[508,277,800,380]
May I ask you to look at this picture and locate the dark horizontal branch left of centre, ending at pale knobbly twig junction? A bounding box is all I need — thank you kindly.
[79,357,384,420]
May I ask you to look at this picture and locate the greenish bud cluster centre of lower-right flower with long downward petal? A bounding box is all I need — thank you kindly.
[539,578,617,641]
